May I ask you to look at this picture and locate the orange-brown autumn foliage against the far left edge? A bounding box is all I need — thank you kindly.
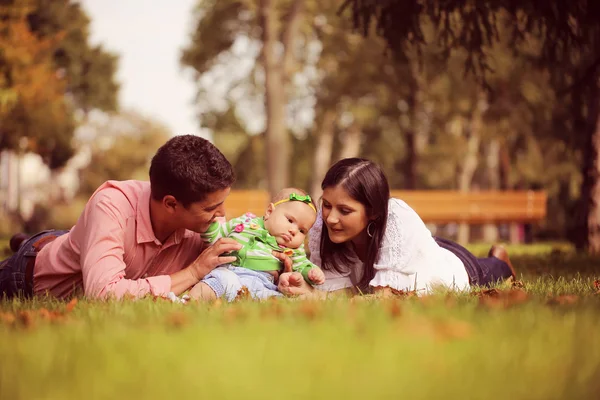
[0,1,73,167]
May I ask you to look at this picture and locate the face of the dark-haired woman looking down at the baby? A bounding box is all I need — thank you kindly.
[322,185,369,243]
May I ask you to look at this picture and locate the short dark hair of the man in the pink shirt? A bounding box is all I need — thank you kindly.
[150,135,235,208]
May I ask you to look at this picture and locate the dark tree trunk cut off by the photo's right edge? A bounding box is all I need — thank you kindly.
[581,87,600,254]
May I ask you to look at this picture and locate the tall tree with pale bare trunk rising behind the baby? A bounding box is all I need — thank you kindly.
[181,0,305,197]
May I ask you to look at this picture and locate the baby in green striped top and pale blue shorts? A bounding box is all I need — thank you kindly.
[190,188,325,301]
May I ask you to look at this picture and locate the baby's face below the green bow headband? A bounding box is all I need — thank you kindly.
[265,201,317,249]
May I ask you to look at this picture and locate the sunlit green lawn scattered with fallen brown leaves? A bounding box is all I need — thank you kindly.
[0,245,600,400]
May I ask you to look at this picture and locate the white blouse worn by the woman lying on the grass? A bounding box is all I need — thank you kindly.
[308,198,469,294]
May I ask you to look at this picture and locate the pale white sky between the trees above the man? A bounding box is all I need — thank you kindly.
[80,0,206,136]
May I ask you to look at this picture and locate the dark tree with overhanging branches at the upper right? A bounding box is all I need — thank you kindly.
[342,0,600,253]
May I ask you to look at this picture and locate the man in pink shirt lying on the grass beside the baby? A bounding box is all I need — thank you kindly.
[0,135,241,298]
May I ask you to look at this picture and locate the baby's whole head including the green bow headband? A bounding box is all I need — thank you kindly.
[264,188,317,249]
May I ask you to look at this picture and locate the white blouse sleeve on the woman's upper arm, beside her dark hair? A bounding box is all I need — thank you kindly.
[369,199,424,290]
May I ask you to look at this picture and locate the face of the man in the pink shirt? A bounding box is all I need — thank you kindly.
[178,188,231,233]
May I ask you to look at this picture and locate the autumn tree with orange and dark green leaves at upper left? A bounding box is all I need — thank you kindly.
[0,0,118,169]
